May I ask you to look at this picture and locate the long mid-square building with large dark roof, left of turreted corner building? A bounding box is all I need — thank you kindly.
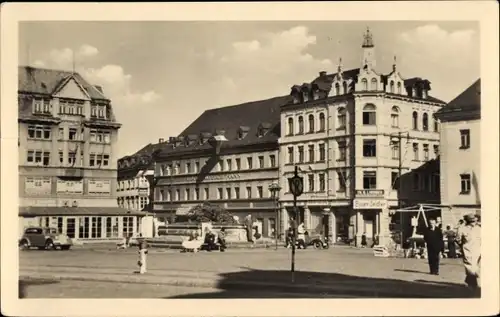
[154,96,289,236]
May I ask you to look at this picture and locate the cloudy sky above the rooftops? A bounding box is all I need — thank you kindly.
[19,21,480,157]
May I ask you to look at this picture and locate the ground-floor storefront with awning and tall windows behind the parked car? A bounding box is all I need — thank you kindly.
[19,207,144,242]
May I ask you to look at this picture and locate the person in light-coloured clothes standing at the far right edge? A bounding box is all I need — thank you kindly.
[459,214,481,290]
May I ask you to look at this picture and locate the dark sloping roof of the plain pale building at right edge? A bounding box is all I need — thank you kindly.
[435,78,481,121]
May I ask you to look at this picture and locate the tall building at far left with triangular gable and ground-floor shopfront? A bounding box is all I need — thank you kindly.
[18,67,142,241]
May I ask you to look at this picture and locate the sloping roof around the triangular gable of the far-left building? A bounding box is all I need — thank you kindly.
[18,66,109,100]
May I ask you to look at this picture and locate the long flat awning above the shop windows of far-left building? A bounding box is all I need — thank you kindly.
[19,206,146,217]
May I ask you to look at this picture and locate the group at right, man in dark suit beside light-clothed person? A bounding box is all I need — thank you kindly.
[424,214,481,289]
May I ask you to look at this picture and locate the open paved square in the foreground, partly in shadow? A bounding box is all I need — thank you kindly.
[20,248,471,298]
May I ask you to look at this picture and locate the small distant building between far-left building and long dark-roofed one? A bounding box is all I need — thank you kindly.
[116,139,163,237]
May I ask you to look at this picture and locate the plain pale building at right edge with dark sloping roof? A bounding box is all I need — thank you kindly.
[435,79,481,225]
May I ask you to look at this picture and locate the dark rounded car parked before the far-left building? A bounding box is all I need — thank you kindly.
[19,227,73,250]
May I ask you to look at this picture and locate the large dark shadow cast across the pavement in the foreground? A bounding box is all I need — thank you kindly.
[168,268,478,298]
